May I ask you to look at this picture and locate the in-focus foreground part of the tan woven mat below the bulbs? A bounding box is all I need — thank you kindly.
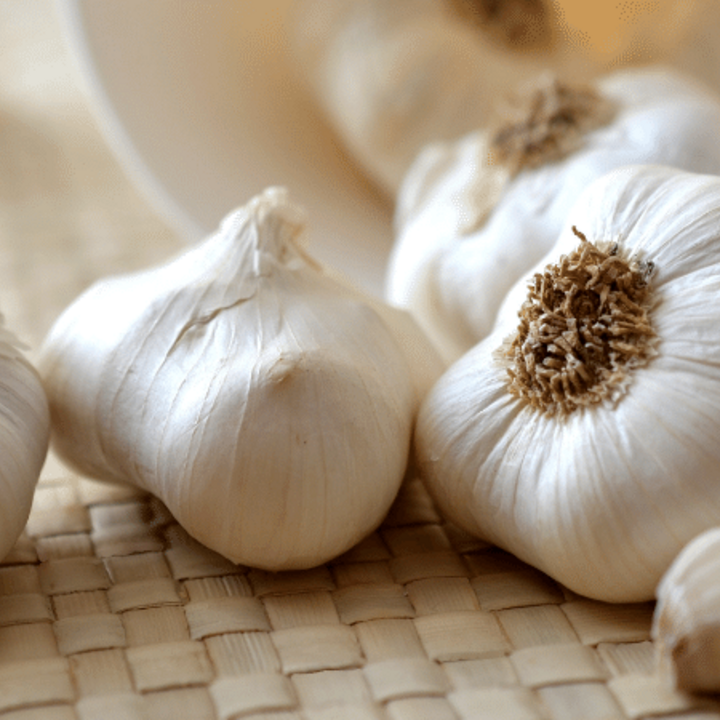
[7,474,720,720]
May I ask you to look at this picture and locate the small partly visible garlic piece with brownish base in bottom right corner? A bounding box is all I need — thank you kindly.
[652,527,720,693]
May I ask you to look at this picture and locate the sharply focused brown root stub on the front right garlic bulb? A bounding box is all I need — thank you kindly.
[500,227,656,415]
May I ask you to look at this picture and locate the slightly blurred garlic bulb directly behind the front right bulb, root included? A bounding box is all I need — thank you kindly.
[386,68,720,360]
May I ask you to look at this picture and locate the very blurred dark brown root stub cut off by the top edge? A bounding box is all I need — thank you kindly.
[451,0,552,51]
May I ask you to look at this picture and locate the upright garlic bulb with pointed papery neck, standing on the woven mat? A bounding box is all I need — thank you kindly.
[40,188,441,570]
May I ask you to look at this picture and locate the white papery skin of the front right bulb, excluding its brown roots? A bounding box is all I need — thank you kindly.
[415,166,720,602]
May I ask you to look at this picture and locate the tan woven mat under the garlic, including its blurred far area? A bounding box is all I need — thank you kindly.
[0,0,720,720]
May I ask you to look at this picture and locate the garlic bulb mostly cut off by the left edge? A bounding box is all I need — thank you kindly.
[0,316,50,560]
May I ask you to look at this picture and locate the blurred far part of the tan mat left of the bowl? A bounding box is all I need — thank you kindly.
[0,0,181,355]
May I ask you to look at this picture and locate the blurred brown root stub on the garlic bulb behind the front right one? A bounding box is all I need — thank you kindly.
[490,77,615,173]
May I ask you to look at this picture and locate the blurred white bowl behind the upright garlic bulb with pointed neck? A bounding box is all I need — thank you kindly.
[57,0,392,294]
